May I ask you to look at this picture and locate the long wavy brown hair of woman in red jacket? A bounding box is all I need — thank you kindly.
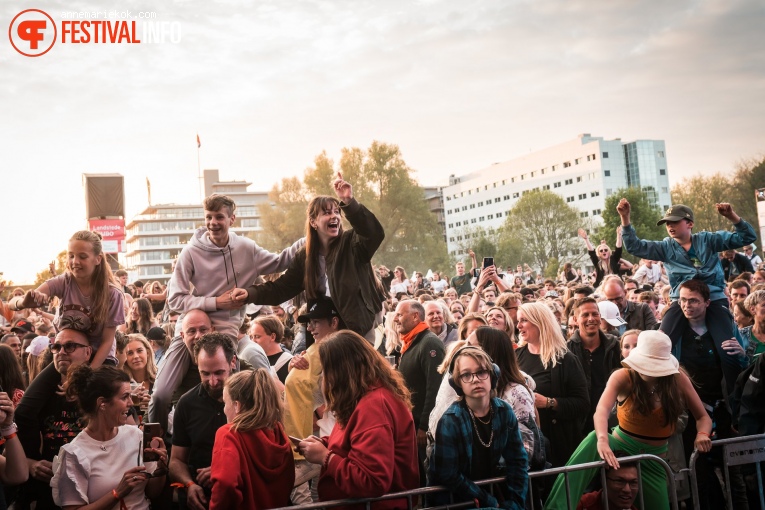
[319,329,412,427]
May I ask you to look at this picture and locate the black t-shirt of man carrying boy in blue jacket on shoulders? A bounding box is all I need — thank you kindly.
[678,328,723,406]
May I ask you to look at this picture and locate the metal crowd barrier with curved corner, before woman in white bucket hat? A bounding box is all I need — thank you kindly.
[275,454,678,510]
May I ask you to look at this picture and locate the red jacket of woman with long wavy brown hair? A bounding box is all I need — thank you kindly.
[319,387,420,510]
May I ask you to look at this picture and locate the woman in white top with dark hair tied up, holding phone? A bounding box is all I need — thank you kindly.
[50,364,167,510]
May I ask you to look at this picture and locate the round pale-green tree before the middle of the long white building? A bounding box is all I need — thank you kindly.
[502,191,581,274]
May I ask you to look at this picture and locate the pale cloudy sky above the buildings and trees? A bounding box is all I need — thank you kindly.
[0,0,765,283]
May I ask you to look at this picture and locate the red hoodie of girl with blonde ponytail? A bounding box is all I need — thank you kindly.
[210,423,295,510]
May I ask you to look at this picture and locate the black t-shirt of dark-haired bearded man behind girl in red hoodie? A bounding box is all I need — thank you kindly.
[173,383,226,479]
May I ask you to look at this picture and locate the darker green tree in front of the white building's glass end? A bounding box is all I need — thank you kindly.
[590,187,667,262]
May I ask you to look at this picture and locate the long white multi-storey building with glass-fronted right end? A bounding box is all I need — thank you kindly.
[443,134,672,256]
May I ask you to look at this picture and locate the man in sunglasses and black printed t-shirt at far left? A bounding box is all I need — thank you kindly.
[16,329,93,510]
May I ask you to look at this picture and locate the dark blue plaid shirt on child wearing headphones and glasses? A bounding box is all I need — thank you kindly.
[428,398,529,510]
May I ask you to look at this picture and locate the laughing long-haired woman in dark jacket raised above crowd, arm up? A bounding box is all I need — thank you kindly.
[231,172,386,343]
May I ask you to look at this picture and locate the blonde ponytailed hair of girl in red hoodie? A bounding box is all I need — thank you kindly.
[225,368,282,432]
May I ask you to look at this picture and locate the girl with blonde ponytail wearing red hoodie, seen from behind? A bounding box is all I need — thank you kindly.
[210,368,295,510]
